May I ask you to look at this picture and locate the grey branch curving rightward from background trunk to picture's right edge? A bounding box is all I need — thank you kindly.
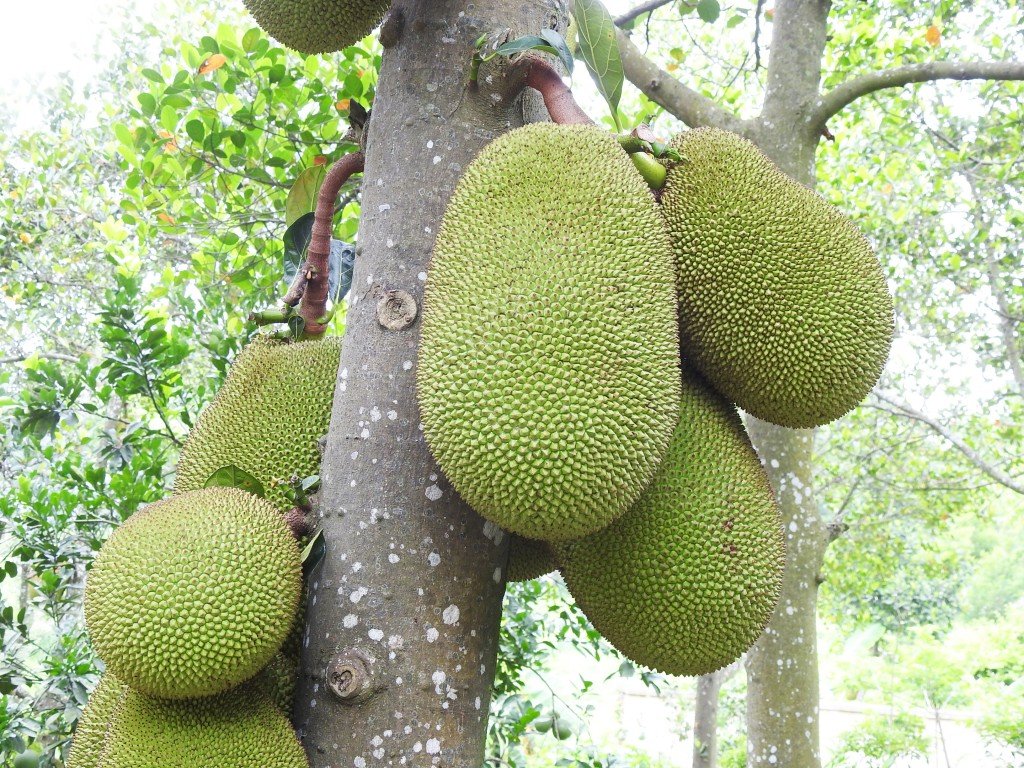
[811,61,1024,129]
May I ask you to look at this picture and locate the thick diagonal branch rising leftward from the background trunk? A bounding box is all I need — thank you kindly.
[618,30,743,133]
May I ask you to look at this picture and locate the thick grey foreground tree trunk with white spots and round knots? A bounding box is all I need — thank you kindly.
[295,0,565,768]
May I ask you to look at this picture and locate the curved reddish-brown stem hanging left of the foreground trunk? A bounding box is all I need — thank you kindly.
[299,152,365,336]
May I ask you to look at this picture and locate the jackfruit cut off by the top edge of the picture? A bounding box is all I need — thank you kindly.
[245,0,391,55]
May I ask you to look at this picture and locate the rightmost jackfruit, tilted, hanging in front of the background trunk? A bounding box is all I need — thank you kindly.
[662,128,894,428]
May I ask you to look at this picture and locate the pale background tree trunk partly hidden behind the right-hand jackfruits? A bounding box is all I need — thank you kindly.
[746,0,830,768]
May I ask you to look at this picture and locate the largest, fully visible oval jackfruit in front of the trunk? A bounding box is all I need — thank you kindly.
[417,123,679,541]
